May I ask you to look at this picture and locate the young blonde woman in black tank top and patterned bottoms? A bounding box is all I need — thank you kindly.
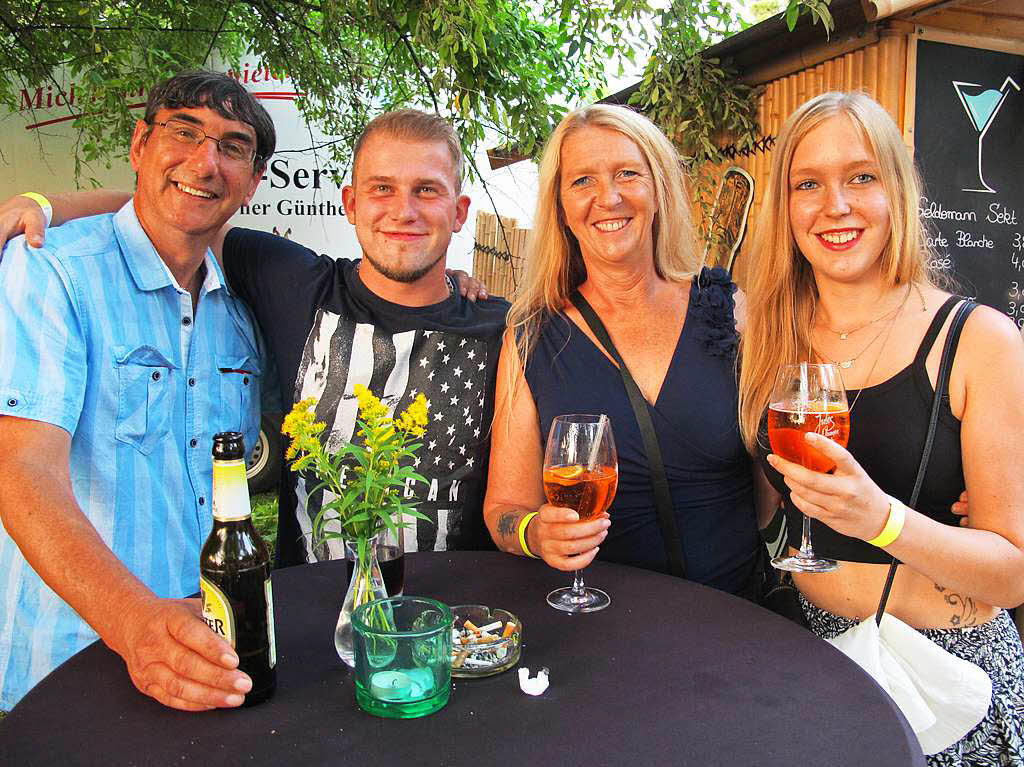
[739,93,1024,765]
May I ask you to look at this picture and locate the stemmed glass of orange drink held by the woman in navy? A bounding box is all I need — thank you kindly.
[544,415,618,612]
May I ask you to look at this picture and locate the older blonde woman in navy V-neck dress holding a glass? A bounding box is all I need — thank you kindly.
[484,105,761,595]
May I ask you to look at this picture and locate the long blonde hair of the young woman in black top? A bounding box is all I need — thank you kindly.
[739,91,932,450]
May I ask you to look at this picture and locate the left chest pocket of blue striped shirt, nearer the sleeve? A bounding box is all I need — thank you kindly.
[114,345,177,456]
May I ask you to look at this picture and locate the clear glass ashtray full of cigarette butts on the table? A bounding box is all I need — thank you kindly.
[452,604,522,678]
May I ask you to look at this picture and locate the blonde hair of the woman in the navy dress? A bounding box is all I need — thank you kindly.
[508,104,701,368]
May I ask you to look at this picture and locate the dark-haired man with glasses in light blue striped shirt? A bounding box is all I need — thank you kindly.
[0,72,275,711]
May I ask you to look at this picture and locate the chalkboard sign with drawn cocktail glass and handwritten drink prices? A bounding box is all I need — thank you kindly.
[913,40,1024,328]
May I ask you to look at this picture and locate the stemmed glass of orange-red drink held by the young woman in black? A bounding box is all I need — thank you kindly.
[768,363,850,572]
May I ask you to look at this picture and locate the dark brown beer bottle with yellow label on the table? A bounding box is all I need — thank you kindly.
[199,431,278,706]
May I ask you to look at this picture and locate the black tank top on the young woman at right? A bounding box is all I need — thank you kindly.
[758,296,965,564]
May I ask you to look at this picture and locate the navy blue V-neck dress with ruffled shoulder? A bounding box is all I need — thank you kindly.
[525,268,762,594]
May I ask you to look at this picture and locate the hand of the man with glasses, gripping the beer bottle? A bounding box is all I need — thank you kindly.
[110,598,253,711]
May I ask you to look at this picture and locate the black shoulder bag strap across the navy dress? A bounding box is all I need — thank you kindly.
[569,291,686,578]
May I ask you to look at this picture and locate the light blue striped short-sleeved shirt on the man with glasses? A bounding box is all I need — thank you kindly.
[0,202,272,709]
